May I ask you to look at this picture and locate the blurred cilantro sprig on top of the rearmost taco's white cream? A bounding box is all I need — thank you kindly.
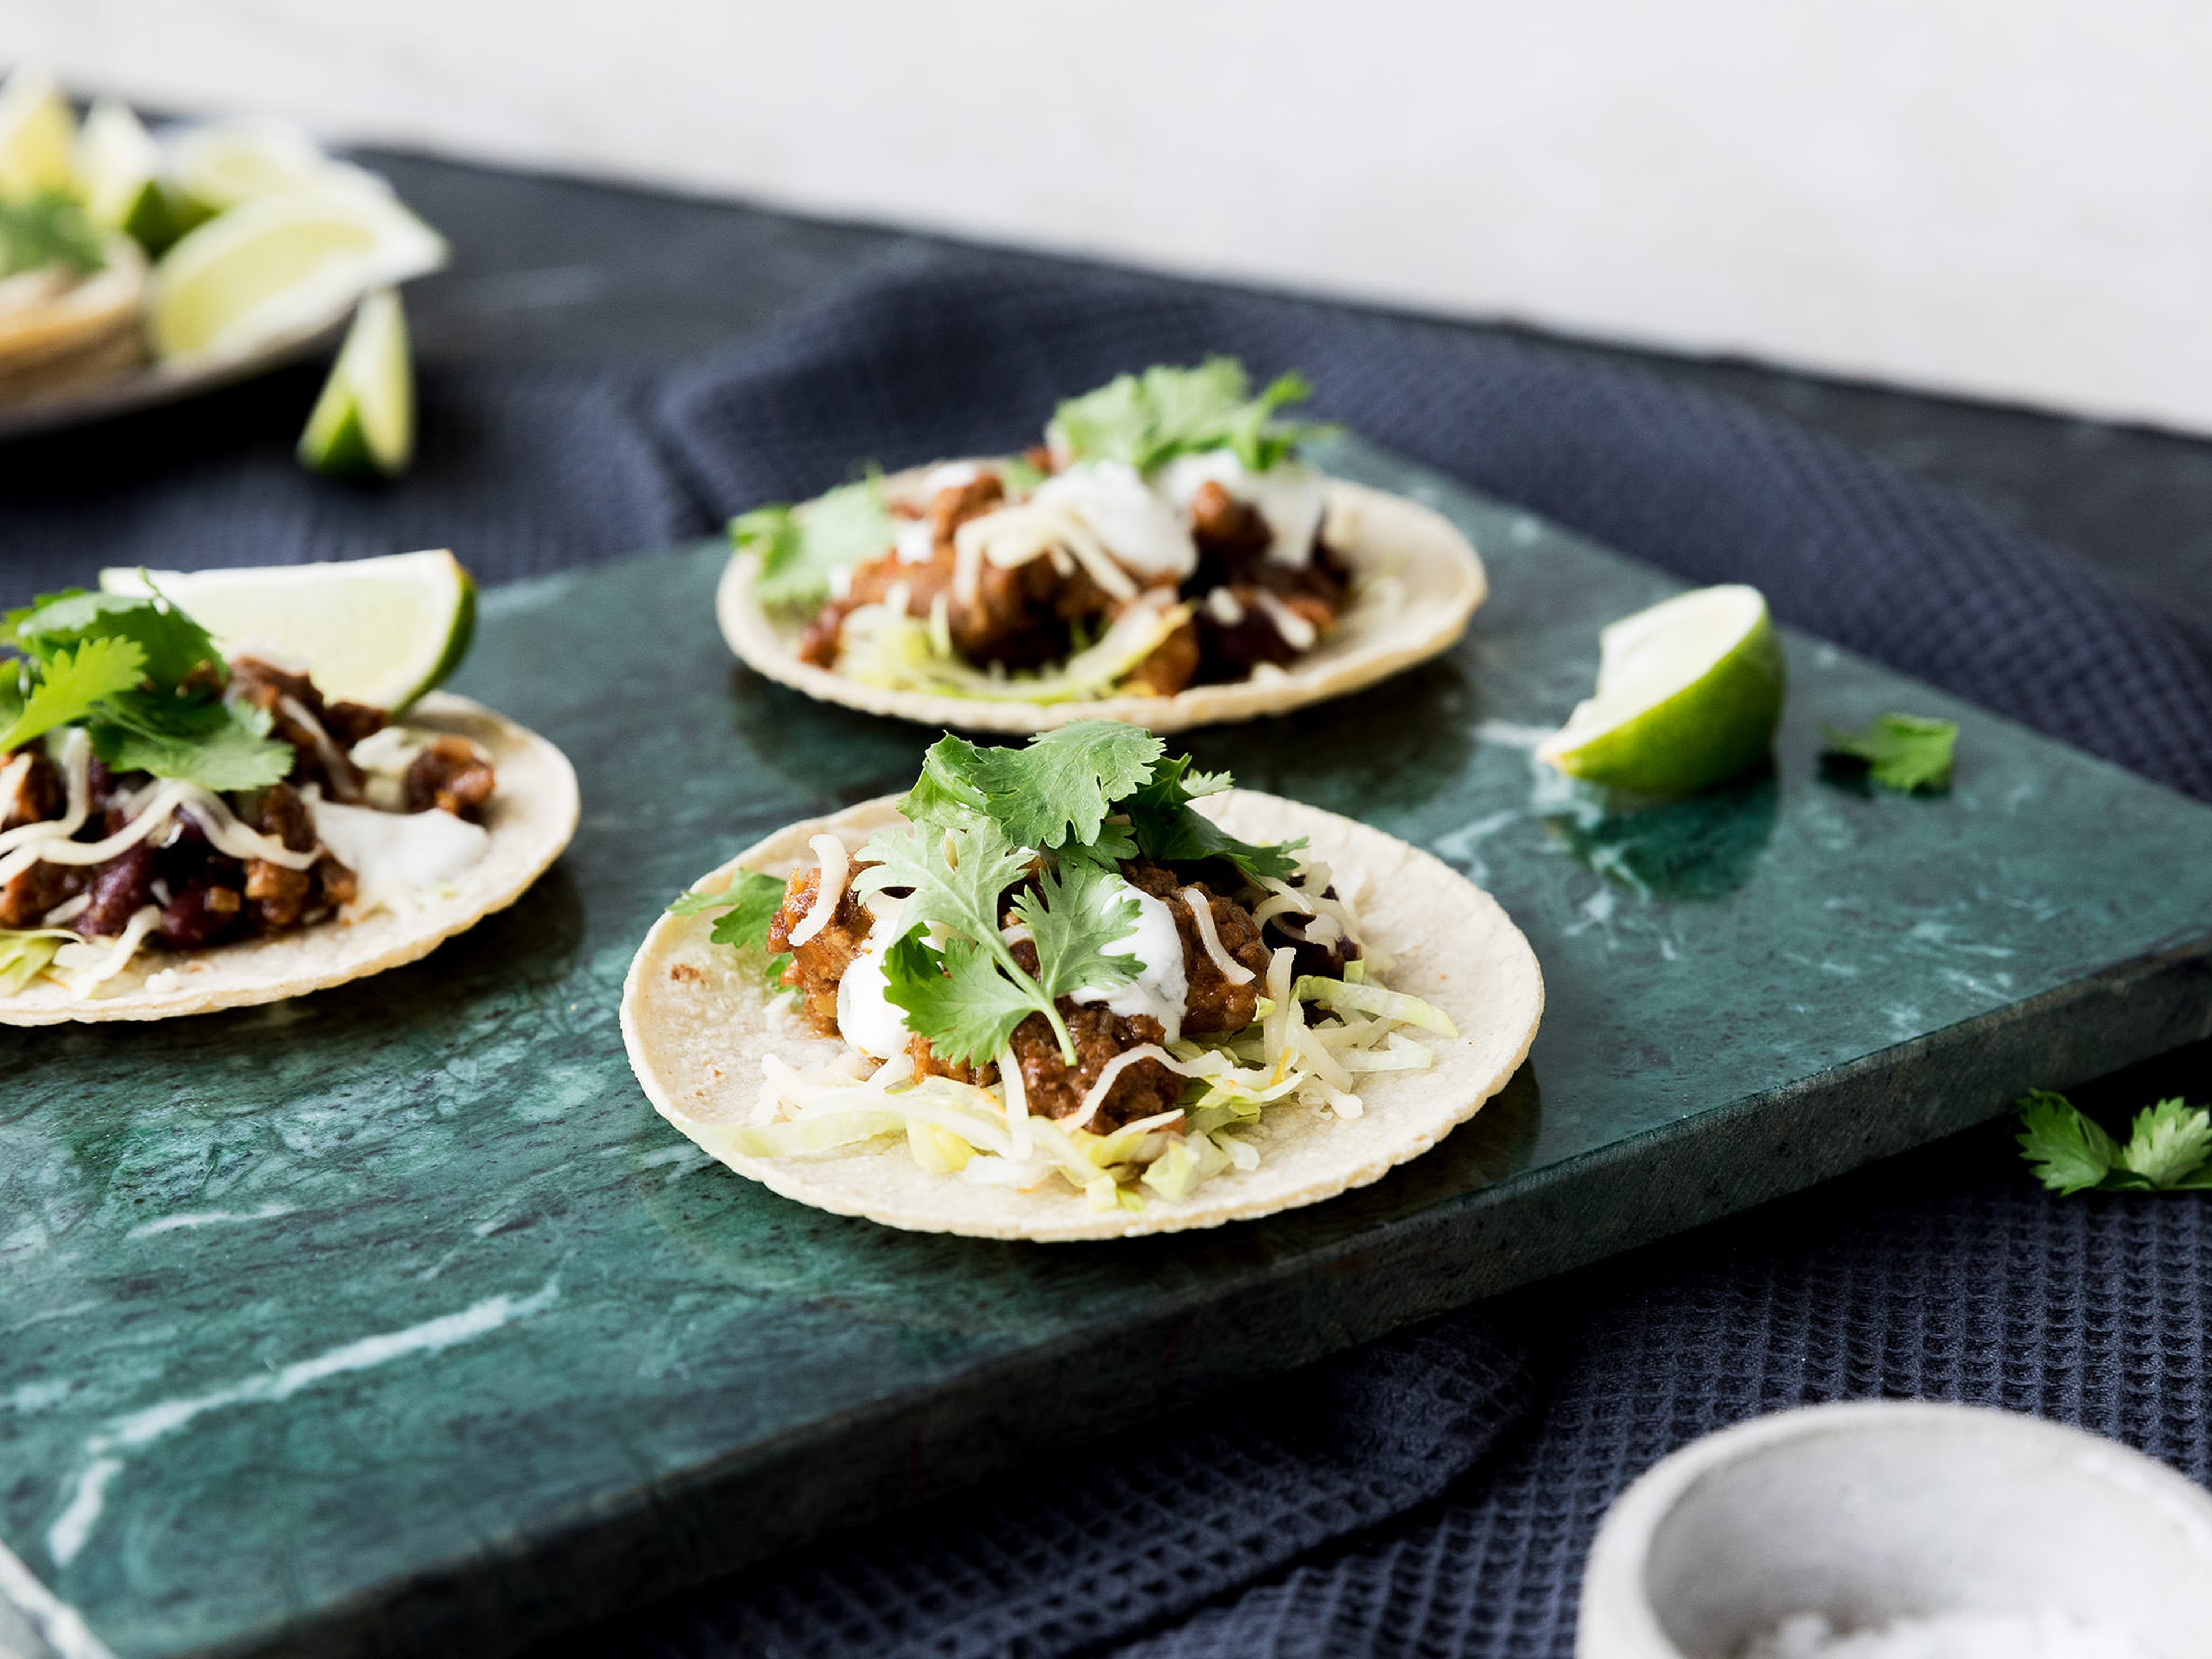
[1053,356,1330,474]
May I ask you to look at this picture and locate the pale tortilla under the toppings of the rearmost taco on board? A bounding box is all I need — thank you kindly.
[714,474,1488,732]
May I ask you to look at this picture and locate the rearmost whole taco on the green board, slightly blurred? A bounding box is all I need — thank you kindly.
[717,358,1486,732]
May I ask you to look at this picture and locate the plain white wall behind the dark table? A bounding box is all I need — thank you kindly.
[0,0,2212,431]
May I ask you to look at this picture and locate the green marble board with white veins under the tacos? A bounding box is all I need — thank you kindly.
[0,445,2212,1659]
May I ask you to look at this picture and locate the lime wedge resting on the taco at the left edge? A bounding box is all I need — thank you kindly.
[100,551,476,710]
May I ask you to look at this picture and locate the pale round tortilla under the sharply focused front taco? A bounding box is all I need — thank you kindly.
[622,790,1544,1241]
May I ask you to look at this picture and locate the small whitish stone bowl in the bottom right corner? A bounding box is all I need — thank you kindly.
[1575,1400,2212,1659]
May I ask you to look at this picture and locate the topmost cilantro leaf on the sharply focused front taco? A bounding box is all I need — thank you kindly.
[900,721,1168,847]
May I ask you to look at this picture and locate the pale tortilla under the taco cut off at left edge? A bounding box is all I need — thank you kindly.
[0,692,577,1027]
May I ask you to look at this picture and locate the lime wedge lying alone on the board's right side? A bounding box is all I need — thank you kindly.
[1537,584,1785,794]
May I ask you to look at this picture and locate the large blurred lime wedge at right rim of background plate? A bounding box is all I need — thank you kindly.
[146,177,447,358]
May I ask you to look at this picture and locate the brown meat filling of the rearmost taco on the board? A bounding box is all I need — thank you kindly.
[798,474,1351,697]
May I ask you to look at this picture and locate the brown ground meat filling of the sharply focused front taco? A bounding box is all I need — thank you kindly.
[791,861,1267,1135]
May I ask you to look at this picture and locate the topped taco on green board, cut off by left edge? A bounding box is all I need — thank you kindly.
[0,553,577,1024]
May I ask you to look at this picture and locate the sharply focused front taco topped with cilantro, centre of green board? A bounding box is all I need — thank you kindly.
[622,721,1544,1238]
